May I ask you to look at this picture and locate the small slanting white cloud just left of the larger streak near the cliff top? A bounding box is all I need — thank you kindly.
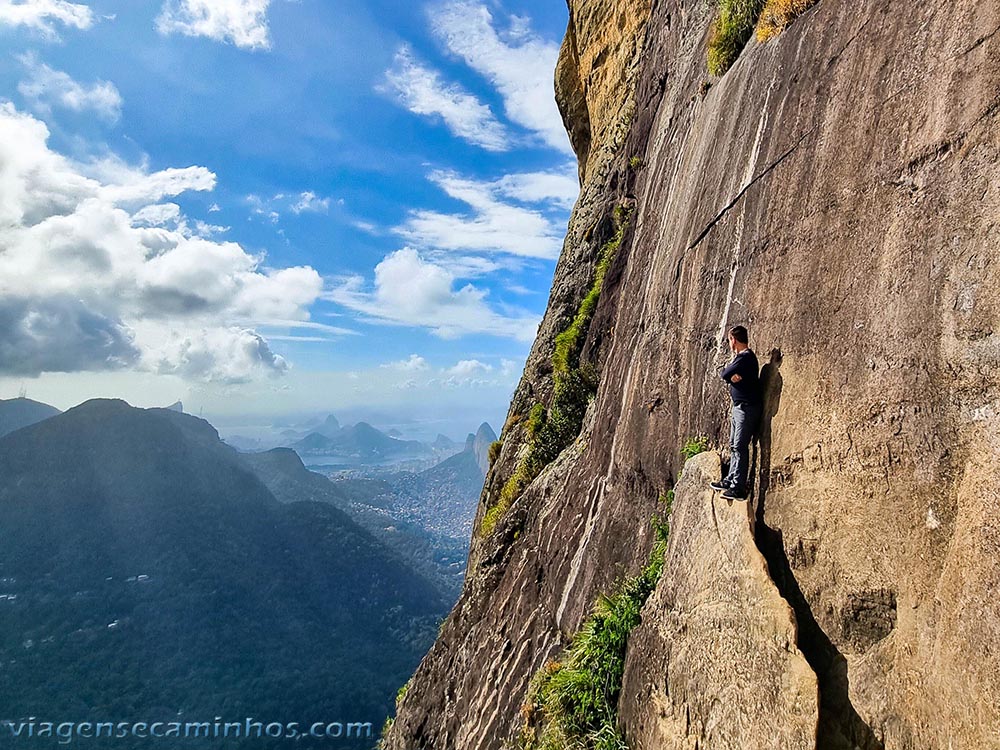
[383,45,510,151]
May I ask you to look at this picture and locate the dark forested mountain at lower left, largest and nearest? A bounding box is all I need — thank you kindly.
[0,399,450,746]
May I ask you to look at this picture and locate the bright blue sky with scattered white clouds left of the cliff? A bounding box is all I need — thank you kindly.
[0,0,576,438]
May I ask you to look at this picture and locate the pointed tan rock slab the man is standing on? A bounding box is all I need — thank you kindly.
[623,452,819,750]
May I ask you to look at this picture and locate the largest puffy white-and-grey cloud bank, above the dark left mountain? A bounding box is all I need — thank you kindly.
[0,102,322,382]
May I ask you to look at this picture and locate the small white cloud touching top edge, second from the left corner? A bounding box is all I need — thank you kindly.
[156,0,271,49]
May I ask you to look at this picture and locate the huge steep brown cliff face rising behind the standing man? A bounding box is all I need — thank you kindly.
[378,0,1000,750]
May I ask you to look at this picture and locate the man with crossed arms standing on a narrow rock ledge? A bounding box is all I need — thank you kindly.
[712,326,762,500]
